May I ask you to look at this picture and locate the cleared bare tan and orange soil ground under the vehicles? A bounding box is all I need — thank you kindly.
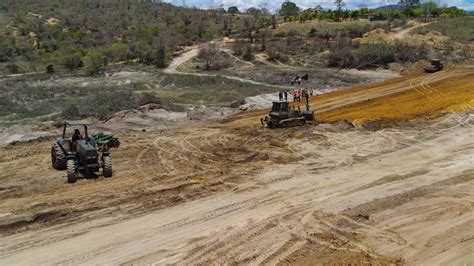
[0,67,474,265]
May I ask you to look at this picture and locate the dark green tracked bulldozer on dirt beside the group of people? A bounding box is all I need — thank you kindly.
[260,101,314,128]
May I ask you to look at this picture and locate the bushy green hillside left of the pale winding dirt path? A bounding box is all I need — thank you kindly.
[0,0,228,72]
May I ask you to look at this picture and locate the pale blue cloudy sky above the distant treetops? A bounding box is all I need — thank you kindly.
[164,0,474,11]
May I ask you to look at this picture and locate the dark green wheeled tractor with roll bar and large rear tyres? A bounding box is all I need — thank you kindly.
[51,122,112,183]
